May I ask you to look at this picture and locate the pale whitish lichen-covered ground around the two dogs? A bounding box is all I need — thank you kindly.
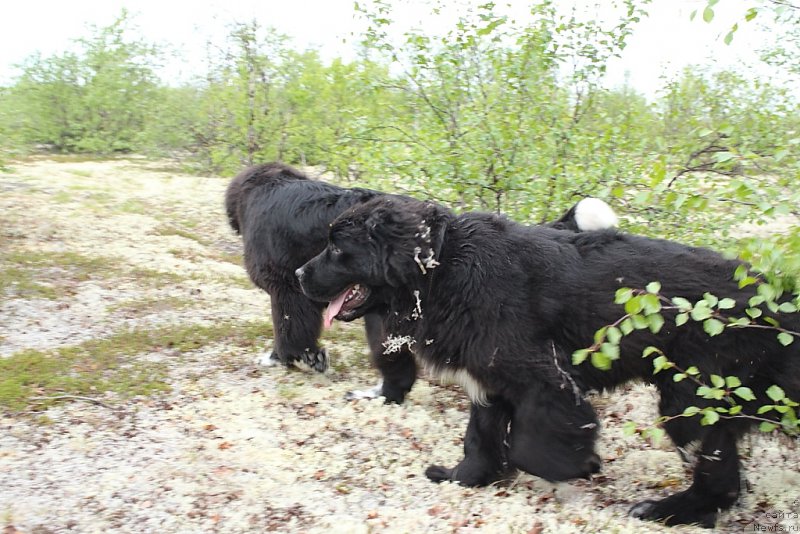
[0,159,800,534]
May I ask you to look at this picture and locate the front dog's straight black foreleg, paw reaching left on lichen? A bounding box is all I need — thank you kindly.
[425,398,511,486]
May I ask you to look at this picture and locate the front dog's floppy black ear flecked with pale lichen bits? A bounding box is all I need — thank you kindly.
[365,199,450,287]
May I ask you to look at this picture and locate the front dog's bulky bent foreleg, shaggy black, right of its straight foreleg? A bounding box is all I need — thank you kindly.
[508,384,600,481]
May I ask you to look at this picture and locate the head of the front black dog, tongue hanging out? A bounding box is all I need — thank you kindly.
[296,195,451,326]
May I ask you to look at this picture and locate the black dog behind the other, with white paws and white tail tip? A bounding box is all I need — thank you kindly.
[225,163,616,403]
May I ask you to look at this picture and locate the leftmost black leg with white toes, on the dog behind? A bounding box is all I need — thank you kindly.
[270,290,328,373]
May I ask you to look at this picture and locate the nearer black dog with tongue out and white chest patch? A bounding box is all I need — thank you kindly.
[297,198,800,527]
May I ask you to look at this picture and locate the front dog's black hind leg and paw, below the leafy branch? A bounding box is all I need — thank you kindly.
[630,422,741,528]
